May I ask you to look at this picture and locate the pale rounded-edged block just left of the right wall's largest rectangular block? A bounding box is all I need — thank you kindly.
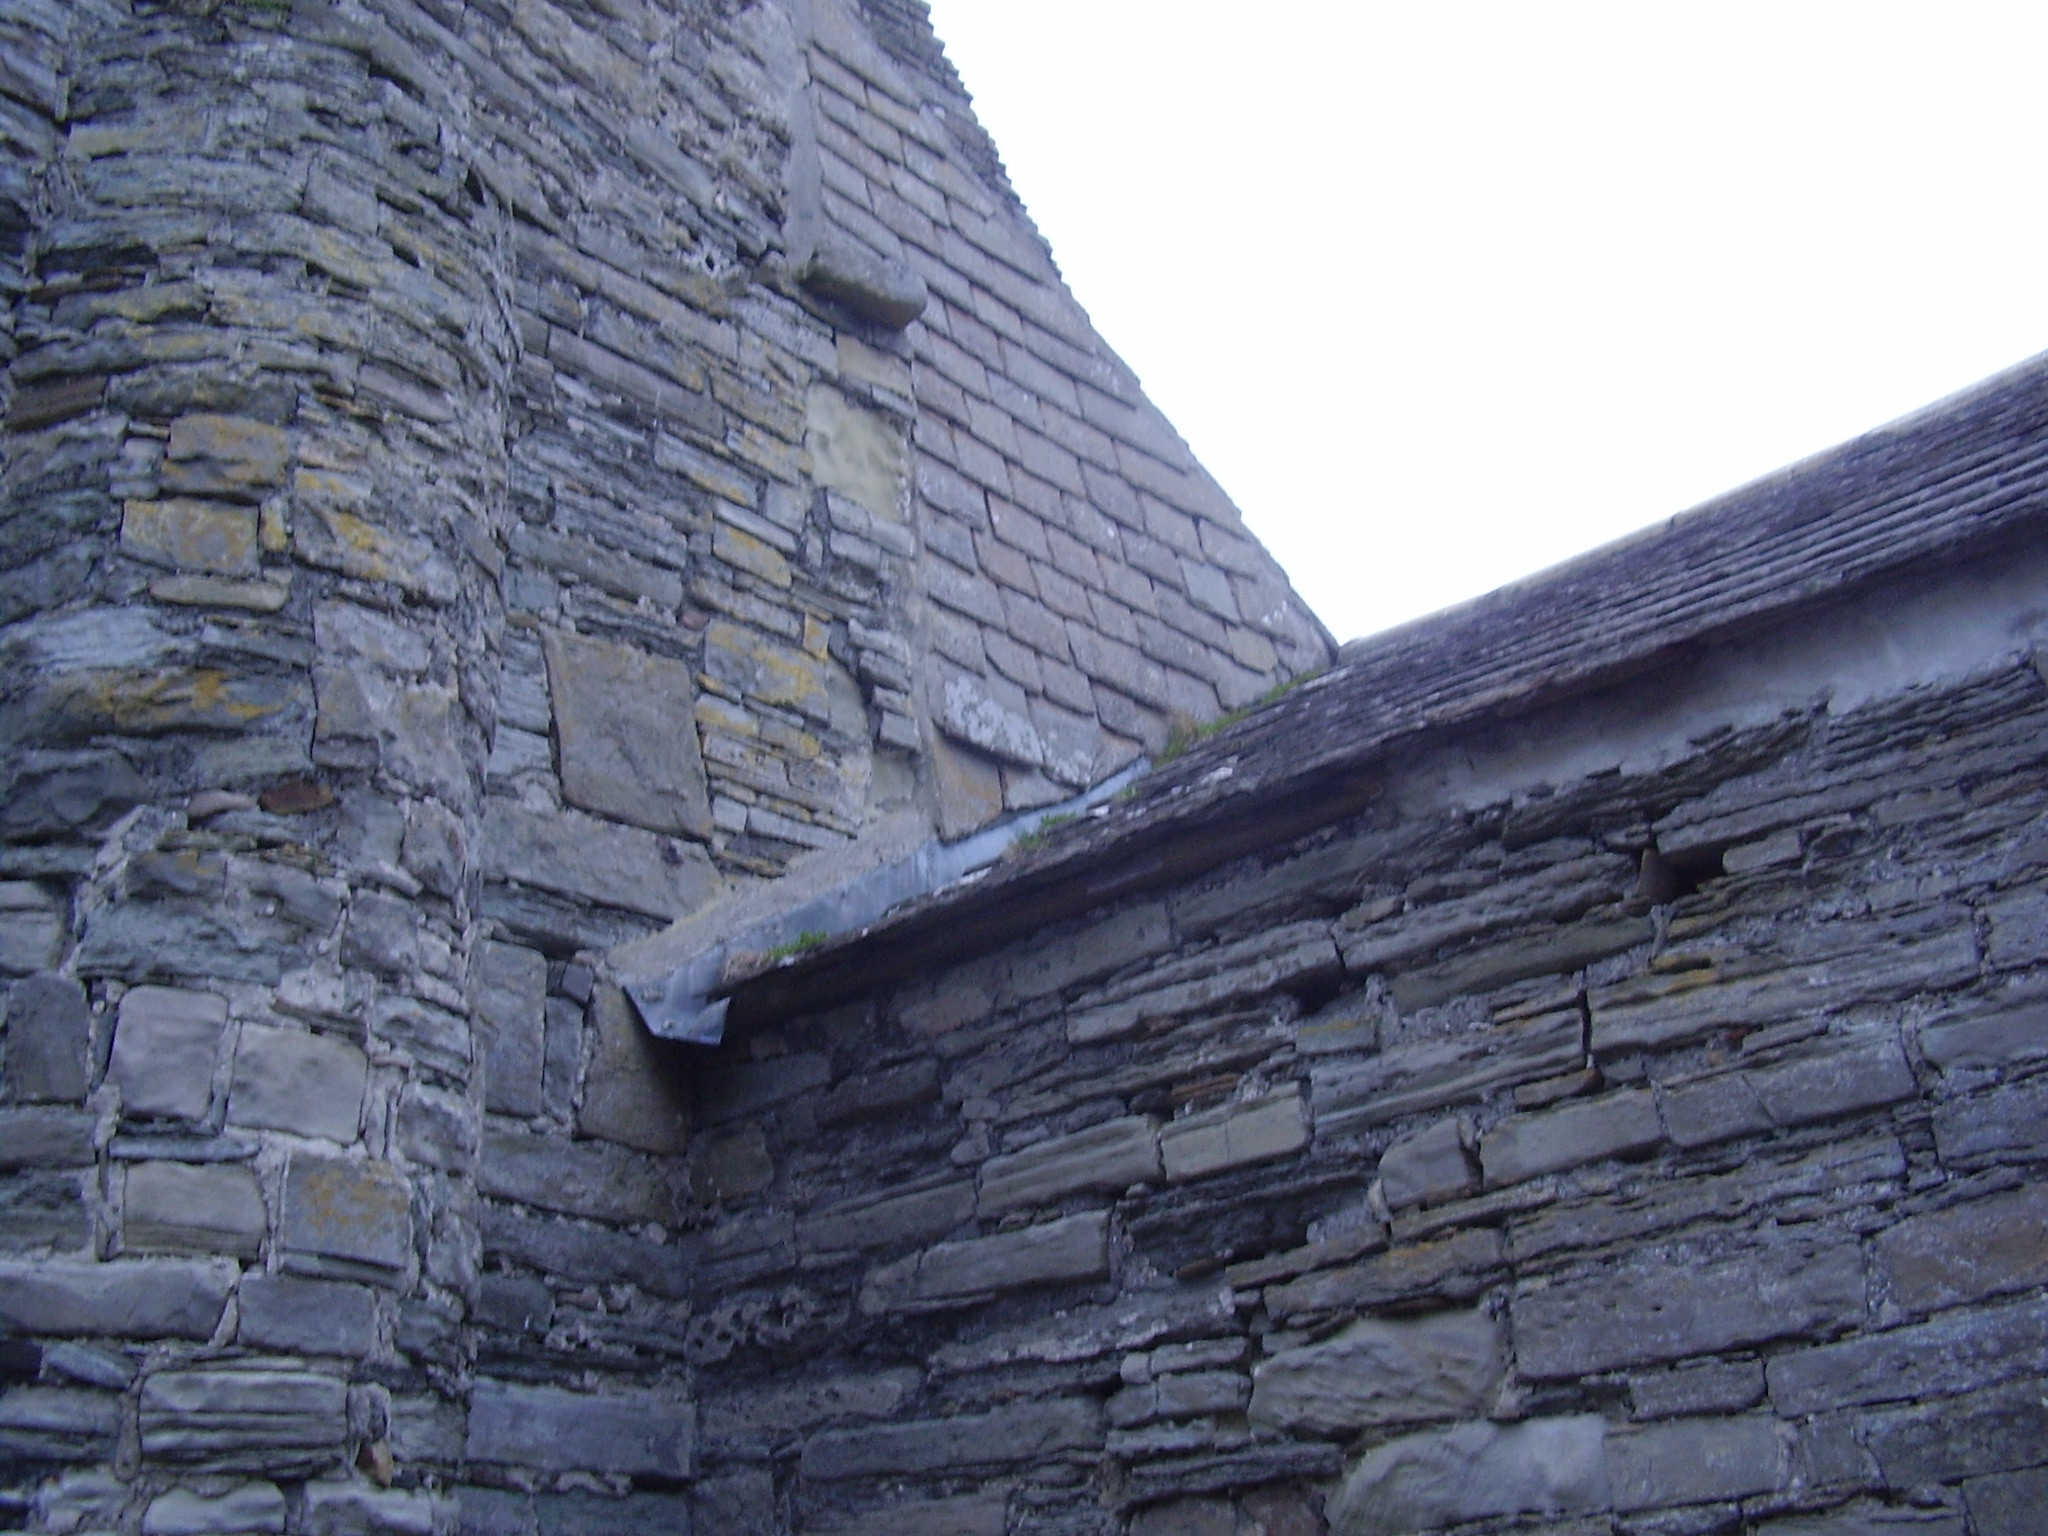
[1251,1311,1505,1436]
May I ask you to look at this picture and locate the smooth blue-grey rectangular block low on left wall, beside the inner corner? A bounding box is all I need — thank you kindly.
[463,1378,696,1477]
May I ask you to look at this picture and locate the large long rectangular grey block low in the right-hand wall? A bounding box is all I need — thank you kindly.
[1513,1235,1864,1380]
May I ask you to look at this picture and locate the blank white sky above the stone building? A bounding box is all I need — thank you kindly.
[932,0,2048,639]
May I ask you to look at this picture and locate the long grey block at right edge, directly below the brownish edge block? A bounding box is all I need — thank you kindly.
[1767,1300,2048,1413]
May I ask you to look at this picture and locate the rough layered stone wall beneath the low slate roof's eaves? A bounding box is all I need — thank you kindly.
[671,541,2048,1536]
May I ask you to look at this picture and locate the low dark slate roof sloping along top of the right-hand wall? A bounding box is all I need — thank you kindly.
[733,342,2048,1020]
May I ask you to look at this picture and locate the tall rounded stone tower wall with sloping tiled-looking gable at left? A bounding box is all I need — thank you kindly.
[0,0,1329,1536]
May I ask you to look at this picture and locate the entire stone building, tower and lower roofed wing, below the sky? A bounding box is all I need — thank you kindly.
[0,0,2048,1536]
